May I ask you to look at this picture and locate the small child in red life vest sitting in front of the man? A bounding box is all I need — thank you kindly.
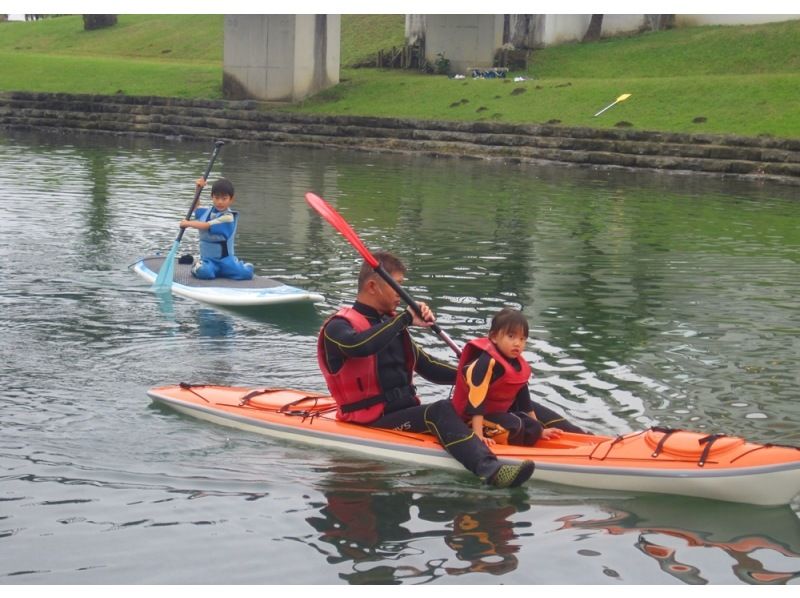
[453,308,585,446]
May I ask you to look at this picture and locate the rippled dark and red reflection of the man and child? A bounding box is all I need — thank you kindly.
[307,484,530,584]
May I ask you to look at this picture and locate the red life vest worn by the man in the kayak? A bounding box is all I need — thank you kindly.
[317,307,414,424]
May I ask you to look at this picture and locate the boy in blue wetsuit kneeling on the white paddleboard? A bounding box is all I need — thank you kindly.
[181,177,253,280]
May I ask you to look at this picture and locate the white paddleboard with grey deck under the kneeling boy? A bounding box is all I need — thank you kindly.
[132,256,325,307]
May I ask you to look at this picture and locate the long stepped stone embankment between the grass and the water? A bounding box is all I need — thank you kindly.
[0,92,800,185]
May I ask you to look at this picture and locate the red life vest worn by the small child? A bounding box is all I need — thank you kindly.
[453,338,531,419]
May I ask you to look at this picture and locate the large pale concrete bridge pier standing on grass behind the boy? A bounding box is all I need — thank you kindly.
[222,15,341,102]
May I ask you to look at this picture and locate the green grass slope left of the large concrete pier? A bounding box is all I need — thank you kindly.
[0,15,223,98]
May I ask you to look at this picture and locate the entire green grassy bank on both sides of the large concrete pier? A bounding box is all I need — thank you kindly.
[0,15,800,137]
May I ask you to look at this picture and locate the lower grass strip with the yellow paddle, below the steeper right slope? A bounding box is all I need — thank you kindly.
[291,72,800,137]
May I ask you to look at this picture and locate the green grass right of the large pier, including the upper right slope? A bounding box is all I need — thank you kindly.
[293,21,800,137]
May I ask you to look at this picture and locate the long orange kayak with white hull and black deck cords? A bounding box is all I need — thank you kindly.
[148,384,800,505]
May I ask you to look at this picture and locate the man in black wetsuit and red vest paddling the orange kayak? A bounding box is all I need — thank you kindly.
[317,252,534,488]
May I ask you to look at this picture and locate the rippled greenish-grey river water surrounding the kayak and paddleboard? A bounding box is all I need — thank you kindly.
[0,133,800,586]
